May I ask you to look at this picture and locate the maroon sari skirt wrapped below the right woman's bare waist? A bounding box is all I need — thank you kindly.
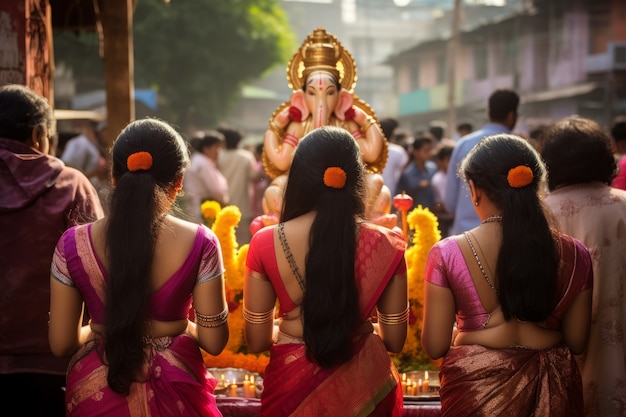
[439,344,583,417]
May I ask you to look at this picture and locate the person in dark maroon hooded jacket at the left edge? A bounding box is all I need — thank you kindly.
[0,85,103,417]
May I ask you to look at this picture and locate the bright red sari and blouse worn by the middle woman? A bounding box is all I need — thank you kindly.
[247,224,406,417]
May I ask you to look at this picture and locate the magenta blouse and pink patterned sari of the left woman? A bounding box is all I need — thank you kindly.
[52,225,223,417]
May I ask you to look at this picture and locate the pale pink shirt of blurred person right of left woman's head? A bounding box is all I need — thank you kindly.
[183,152,230,223]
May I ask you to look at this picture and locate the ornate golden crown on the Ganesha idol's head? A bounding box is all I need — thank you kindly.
[287,28,356,91]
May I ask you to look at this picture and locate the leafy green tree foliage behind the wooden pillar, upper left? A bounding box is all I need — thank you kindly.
[55,0,295,127]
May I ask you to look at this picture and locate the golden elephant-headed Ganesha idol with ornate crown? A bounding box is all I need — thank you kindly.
[250,28,397,234]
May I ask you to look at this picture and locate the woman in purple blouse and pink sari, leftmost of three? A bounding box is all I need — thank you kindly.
[49,119,228,417]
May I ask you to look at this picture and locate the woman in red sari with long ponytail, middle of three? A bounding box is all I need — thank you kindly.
[243,127,408,417]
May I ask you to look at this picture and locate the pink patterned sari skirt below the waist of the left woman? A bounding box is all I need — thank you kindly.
[65,335,222,417]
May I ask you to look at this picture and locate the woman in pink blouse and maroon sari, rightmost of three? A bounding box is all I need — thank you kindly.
[422,135,593,417]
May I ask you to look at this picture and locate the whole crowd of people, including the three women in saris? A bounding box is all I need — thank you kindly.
[0,79,626,416]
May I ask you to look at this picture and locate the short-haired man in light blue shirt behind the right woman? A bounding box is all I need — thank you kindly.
[444,89,519,235]
